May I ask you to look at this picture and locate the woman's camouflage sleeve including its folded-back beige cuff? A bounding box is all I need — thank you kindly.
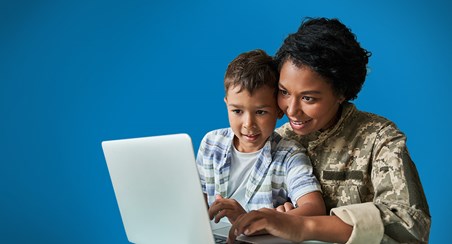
[322,125,430,243]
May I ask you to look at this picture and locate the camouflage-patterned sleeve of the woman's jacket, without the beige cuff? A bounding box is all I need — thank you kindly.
[371,124,431,243]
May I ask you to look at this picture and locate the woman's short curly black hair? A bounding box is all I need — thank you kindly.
[275,18,371,101]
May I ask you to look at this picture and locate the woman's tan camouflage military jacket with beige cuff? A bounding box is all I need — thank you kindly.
[277,103,431,243]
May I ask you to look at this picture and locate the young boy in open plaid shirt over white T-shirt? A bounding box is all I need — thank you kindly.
[196,50,325,223]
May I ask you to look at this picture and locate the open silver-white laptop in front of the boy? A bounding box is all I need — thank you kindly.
[102,134,324,244]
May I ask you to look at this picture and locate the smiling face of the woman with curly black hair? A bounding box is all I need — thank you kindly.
[278,60,344,135]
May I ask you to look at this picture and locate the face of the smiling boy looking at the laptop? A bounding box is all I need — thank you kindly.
[224,86,282,152]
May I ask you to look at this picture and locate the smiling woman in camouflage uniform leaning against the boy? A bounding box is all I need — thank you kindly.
[229,18,430,243]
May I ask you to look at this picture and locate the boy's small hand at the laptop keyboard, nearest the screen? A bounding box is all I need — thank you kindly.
[209,195,246,224]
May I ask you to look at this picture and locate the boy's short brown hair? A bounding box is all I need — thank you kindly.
[224,49,279,96]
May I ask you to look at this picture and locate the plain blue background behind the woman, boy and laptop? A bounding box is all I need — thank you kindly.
[0,0,452,243]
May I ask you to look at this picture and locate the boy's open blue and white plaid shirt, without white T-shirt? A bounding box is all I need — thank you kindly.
[196,128,321,210]
